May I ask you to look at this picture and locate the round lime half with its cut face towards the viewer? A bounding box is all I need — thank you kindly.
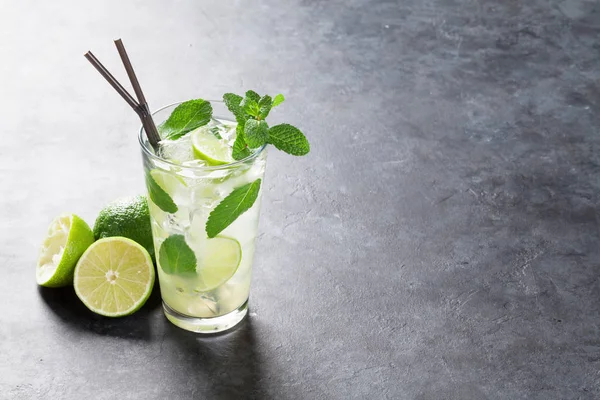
[73,236,154,317]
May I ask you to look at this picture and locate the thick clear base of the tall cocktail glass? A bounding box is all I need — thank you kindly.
[163,300,248,333]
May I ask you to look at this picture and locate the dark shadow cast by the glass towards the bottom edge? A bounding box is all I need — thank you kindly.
[166,317,265,399]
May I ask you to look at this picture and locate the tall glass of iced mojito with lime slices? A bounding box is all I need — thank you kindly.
[140,102,267,333]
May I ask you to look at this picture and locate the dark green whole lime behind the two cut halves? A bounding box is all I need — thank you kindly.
[94,196,154,259]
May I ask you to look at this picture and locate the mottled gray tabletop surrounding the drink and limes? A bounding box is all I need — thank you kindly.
[0,0,600,400]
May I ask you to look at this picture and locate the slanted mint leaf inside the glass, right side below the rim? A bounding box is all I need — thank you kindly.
[206,179,261,238]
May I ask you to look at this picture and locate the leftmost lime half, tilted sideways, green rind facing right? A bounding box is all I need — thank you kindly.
[36,214,94,287]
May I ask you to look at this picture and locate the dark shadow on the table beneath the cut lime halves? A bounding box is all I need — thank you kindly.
[38,282,161,340]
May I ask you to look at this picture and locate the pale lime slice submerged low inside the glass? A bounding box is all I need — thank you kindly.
[196,236,242,291]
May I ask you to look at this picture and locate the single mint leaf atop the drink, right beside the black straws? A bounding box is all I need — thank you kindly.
[158,99,212,140]
